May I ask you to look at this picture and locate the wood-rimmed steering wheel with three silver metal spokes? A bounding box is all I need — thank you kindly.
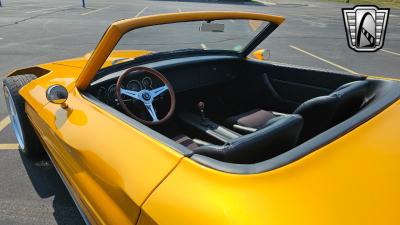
[116,66,176,125]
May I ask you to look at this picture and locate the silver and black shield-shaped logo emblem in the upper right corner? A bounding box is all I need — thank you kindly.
[342,6,390,52]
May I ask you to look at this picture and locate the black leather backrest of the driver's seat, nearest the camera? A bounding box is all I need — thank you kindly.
[193,114,303,163]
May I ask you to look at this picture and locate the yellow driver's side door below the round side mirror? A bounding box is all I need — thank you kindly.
[29,89,183,224]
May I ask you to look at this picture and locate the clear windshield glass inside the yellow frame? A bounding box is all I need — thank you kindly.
[106,19,269,64]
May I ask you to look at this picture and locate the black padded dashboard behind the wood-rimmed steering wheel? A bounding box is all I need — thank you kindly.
[89,56,240,107]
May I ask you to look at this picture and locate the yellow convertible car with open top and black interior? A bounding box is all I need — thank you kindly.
[3,12,400,225]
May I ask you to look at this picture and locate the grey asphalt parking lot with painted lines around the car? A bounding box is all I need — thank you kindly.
[0,0,400,224]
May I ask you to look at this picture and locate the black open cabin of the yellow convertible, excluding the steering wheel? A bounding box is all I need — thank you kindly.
[84,55,388,164]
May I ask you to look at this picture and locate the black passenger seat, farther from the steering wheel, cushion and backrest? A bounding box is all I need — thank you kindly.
[226,80,368,142]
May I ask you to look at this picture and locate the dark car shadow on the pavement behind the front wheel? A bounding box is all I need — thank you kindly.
[20,154,85,225]
